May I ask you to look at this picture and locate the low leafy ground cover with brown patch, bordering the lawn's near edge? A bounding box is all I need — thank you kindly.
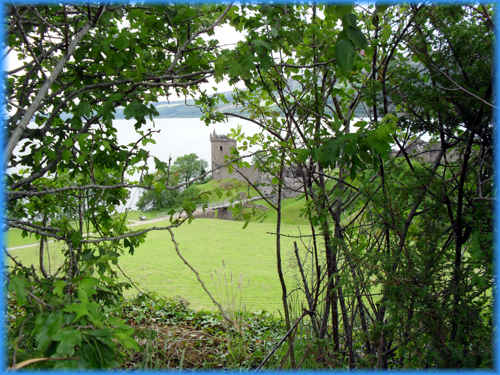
[118,294,282,369]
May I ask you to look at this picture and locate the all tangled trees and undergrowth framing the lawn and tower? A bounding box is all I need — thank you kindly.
[4,4,495,369]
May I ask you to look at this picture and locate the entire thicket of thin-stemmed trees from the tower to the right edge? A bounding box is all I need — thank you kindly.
[200,5,493,368]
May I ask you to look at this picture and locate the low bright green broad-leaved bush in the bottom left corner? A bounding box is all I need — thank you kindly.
[8,268,139,368]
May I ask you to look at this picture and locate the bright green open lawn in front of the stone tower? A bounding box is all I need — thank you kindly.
[8,219,308,312]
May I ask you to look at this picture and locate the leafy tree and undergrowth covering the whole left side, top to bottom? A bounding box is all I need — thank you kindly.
[4,4,231,368]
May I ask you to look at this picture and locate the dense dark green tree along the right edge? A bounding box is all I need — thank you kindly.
[376,6,494,367]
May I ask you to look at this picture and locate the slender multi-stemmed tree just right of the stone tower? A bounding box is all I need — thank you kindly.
[201,6,388,367]
